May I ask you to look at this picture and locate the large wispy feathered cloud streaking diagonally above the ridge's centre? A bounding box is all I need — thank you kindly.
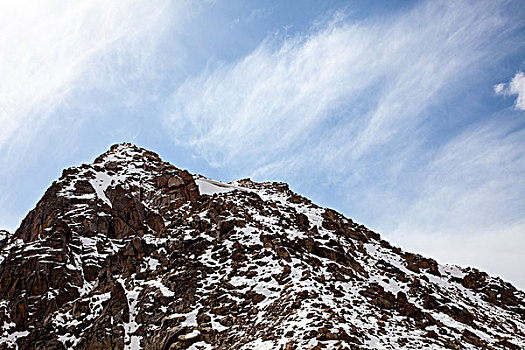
[167,2,520,168]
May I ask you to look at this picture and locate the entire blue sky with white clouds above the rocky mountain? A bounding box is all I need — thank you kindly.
[0,0,525,288]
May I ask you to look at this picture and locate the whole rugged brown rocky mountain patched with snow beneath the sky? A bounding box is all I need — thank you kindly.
[0,144,525,350]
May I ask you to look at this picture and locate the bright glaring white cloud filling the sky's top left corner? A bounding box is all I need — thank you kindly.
[0,0,173,149]
